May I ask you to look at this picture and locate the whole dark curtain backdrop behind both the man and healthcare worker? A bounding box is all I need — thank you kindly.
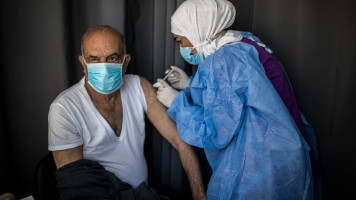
[0,0,356,199]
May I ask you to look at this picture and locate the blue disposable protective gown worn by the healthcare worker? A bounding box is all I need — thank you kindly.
[167,42,313,200]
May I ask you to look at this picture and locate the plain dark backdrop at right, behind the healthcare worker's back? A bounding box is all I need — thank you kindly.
[252,0,356,199]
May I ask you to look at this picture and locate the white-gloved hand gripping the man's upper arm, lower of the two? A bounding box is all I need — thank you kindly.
[157,78,178,108]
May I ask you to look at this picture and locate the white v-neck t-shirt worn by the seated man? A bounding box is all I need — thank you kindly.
[48,75,147,187]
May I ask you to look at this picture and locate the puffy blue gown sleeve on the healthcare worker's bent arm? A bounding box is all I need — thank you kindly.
[167,44,262,150]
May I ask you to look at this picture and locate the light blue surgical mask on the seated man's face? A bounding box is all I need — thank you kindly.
[83,55,126,94]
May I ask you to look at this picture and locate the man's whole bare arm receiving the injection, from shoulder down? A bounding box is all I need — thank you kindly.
[140,78,206,200]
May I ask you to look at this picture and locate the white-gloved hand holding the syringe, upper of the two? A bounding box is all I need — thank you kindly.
[168,66,190,90]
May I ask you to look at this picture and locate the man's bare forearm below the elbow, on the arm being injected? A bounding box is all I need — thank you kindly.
[178,142,206,200]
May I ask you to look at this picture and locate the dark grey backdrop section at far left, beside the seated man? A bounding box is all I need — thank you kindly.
[0,1,68,197]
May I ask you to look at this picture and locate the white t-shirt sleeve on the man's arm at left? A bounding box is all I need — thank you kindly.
[48,103,83,151]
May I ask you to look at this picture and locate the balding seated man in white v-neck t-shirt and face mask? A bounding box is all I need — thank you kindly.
[48,26,206,199]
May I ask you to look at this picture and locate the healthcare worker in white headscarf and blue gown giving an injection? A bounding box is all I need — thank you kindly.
[157,0,319,200]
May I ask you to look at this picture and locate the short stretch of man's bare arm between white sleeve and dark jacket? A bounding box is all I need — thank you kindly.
[52,146,83,169]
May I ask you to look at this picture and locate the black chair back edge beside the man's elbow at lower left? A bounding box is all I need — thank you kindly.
[33,152,59,200]
